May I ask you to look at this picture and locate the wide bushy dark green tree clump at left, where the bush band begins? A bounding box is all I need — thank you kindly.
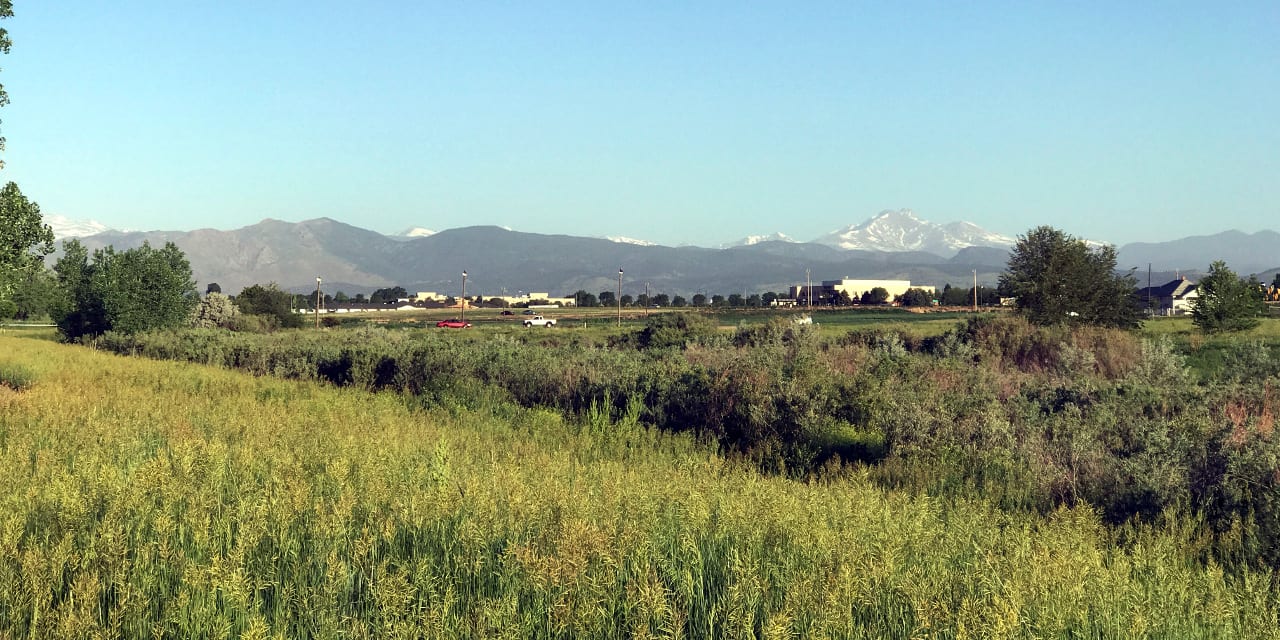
[54,239,198,339]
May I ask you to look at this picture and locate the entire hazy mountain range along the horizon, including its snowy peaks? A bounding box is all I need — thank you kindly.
[47,210,1280,296]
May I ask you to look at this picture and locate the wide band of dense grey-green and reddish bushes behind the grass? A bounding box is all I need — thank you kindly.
[104,317,1280,567]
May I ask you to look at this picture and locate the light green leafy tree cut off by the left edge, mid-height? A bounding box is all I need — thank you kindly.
[0,181,54,300]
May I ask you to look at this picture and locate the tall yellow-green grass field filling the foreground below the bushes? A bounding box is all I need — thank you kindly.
[0,334,1280,639]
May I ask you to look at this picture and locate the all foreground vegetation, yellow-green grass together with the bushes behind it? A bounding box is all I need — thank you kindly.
[0,309,1280,639]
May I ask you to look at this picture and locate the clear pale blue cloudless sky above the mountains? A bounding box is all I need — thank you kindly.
[0,0,1280,246]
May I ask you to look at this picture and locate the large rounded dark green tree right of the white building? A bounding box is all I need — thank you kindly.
[1000,227,1142,328]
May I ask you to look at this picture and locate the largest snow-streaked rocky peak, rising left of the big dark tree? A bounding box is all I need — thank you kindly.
[814,209,1016,257]
